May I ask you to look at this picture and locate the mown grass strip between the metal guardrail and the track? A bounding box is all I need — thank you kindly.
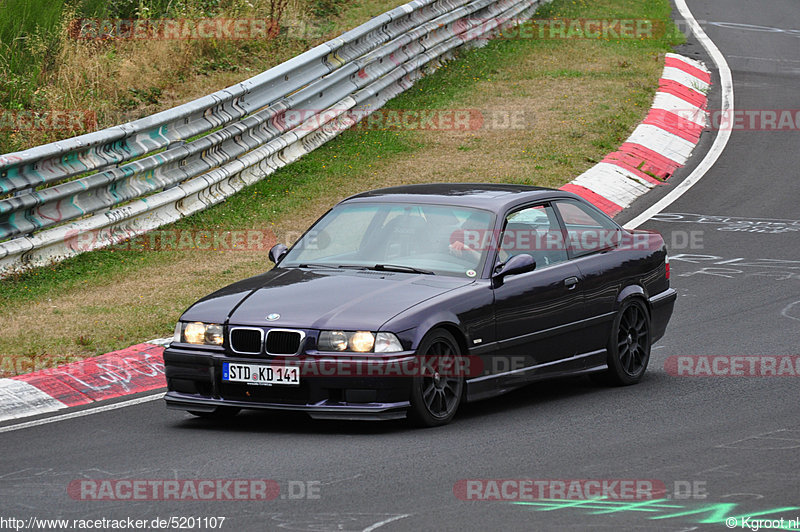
[0,0,688,370]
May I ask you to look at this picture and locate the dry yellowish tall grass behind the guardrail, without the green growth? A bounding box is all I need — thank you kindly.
[0,0,404,153]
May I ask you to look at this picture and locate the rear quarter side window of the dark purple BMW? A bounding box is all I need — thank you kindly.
[555,200,620,257]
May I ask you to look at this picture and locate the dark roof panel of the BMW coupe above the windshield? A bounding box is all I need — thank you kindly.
[342,183,578,212]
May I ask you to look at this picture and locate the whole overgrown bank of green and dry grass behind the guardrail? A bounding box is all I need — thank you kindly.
[0,0,403,153]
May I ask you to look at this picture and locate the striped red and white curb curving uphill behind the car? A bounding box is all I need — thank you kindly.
[561,54,711,216]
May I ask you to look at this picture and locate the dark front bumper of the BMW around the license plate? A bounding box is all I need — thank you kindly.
[164,347,414,419]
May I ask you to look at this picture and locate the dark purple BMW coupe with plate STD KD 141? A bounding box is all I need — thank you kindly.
[164,184,676,426]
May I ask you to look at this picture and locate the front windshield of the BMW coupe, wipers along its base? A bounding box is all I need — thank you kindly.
[281,203,494,277]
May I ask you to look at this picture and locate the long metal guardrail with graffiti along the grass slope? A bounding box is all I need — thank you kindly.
[0,0,549,277]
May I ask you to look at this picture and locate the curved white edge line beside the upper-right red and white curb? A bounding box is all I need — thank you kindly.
[624,0,734,229]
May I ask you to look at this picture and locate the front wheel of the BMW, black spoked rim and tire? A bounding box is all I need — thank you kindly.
[408,329,465,427]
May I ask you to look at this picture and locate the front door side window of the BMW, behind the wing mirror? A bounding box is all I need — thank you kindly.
[499,204,567,270]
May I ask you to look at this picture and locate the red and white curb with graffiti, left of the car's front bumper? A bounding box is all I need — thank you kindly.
[0,338,172,421]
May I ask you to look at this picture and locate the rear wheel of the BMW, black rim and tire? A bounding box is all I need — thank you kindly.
[595,299,651,386]
